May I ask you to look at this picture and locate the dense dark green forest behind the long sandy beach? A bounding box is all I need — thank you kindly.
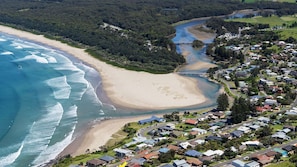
[0,0,297,73]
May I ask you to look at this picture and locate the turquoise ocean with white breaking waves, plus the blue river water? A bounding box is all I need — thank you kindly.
[0,18,220,167]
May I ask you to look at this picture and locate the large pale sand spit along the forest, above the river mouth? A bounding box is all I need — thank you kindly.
[0,26,206,110]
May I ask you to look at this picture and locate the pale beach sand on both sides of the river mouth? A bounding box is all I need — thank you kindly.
[0,26,207,155]
